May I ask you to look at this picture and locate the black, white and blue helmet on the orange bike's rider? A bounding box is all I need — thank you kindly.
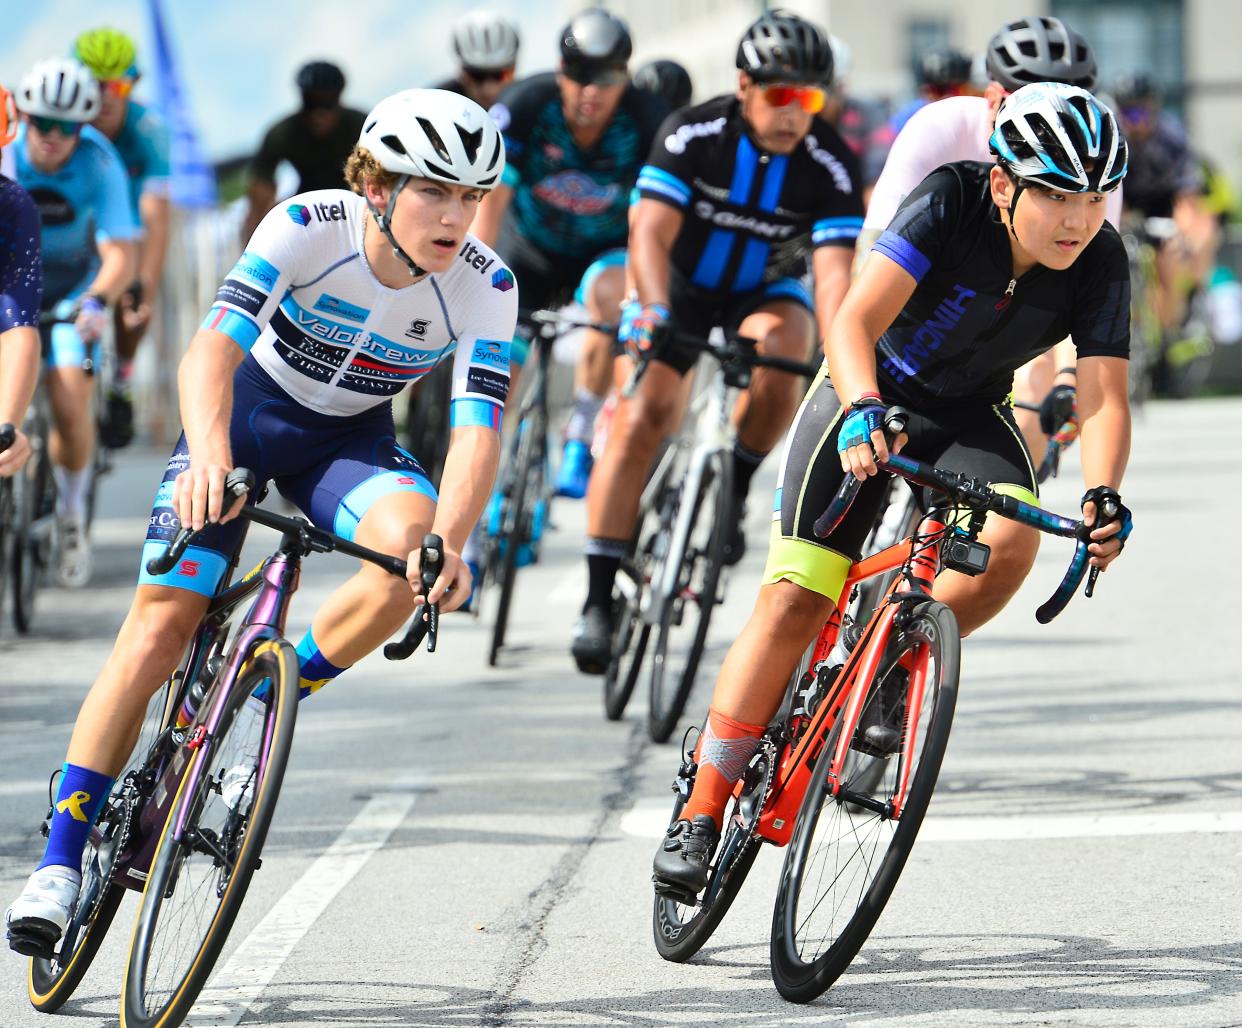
[989,82,1129,192]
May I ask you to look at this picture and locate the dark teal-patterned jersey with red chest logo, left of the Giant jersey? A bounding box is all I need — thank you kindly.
[491,72,668,258]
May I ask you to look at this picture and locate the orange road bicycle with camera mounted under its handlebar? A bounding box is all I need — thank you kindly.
[652,408,1117,1003]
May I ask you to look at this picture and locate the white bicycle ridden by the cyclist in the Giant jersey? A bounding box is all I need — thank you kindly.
[604,333,818,742]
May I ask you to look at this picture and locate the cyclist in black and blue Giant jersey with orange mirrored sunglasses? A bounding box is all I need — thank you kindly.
[573,11,862,674]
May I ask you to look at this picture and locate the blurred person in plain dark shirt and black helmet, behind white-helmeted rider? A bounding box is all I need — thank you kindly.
[242,61,366,241]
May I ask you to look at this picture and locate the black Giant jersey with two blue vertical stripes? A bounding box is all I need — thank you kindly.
[638,96,863,295]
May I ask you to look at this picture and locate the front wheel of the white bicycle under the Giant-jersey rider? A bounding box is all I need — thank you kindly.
[647,451,733,742]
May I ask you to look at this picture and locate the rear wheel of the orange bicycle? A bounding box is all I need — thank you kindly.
[651,749,774,963]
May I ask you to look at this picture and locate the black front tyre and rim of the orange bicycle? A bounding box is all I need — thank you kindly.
[770,600,960,1003]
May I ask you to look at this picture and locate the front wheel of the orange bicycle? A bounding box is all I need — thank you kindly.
[771,601,961,1003]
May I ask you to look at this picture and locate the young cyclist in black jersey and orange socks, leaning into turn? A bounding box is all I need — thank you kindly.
[655,83,1131,891]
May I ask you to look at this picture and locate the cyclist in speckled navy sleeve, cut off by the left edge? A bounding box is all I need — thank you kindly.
[0,86,43,479]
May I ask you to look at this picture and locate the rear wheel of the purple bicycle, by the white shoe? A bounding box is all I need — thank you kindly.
[26,677,181,1013]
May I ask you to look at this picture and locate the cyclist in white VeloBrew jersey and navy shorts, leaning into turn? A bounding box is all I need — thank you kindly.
[6,89,518,955]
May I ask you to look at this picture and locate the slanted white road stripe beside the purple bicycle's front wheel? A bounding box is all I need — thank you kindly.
[188,785,415,1028]
